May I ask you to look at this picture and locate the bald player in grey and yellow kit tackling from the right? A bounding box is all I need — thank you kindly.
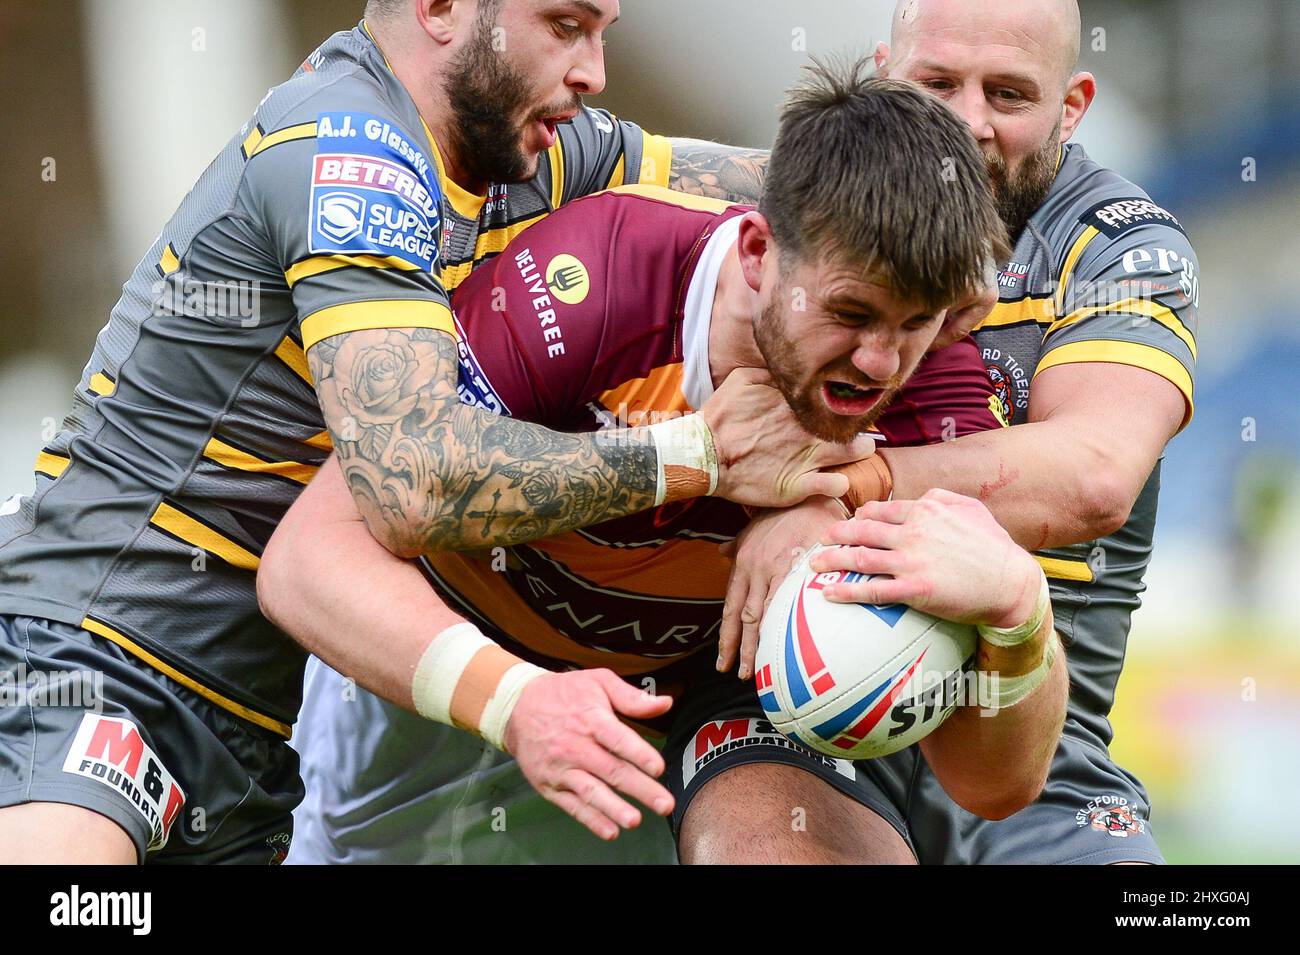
[722,0,1200,863]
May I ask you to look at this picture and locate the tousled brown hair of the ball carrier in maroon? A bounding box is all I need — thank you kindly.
[759,58,1010,311]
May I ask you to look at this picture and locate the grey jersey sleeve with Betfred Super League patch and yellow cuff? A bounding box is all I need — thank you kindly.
[244,107,455,351]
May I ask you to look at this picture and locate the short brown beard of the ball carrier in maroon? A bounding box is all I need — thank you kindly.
[754,288,905,444]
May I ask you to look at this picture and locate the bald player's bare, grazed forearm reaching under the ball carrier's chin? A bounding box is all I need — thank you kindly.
[879,421,1125,551]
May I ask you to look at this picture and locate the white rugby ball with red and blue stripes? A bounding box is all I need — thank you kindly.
[754,544,978,759]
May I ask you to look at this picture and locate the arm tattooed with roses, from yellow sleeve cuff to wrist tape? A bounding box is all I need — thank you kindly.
[307,329,657,557]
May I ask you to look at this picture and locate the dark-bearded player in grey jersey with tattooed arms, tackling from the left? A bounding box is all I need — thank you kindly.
[0,0,863,863]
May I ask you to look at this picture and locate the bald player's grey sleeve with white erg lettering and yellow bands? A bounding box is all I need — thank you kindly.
[1035,197,1200,427]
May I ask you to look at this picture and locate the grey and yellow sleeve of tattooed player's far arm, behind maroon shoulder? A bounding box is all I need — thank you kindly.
[546,107,672,209]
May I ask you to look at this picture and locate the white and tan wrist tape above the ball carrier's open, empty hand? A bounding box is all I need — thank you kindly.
[411,622,546,750]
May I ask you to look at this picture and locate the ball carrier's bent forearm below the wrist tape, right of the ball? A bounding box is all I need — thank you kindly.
[922,631,1069,819]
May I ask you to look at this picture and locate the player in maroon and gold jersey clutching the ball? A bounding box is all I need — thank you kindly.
[259,65,1065,861]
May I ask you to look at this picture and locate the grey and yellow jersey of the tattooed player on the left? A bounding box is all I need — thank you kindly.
[0,23,671,735]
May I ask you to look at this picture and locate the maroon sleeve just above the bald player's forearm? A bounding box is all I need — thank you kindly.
[876,338,1006,447]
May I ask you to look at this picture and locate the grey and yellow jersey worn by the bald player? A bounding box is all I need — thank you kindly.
[975,144,1200,743]
